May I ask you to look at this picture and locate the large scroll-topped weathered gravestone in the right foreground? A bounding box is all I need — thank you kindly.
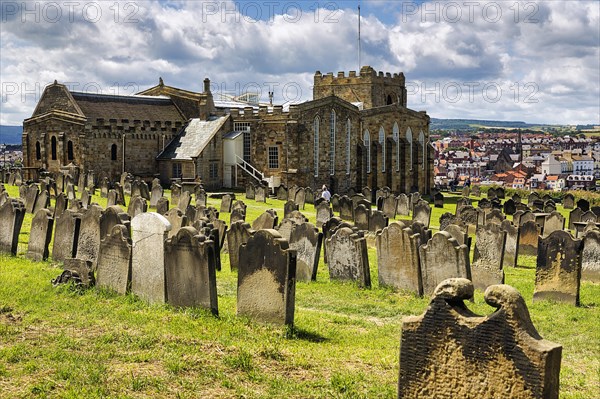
[398,279,562,399]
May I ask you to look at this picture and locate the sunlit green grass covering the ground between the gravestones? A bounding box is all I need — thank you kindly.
[0,187,600,399]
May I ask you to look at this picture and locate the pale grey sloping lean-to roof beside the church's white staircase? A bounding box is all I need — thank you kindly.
[157,115,229,161]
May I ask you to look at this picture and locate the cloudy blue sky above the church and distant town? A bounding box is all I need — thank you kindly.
[0,0,600,125]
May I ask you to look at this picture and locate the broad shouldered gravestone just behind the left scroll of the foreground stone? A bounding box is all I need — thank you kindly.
[419,231,471,295]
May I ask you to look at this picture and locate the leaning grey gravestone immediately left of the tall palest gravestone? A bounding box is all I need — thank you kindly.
[96,224,132,295]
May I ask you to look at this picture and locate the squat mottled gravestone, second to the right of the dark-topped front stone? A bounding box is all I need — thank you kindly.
[326,227,371,288]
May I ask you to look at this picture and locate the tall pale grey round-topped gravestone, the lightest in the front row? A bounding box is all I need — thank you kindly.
[131,212,171,303]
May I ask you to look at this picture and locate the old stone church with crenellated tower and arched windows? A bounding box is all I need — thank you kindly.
[23,66,433,193]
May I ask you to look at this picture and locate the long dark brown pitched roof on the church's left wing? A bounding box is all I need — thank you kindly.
[71,91,185,122]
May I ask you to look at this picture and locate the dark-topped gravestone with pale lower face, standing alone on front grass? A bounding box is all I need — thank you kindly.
[237,229,296,325]
